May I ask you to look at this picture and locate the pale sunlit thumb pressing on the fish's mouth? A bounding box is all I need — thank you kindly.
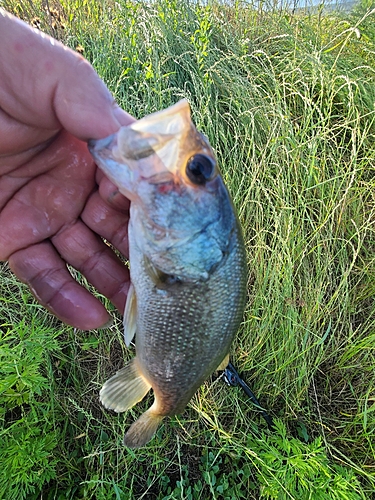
[0,9,134,140]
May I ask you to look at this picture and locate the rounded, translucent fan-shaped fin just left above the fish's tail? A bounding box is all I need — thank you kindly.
[99,358,151,413]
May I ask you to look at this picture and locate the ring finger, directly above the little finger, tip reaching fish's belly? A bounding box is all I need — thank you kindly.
[52,220,130,313]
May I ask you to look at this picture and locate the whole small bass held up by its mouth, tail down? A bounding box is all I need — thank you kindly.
[88,99,247,448]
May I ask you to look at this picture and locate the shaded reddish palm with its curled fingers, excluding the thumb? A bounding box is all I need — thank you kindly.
[0,125,129,329]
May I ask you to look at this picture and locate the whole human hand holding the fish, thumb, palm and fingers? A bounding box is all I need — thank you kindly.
[0,9,134,329]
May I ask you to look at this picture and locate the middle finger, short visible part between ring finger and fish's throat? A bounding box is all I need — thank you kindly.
[81,191,129,257]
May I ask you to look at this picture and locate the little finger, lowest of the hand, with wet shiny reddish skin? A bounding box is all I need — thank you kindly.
[9,242,110,330]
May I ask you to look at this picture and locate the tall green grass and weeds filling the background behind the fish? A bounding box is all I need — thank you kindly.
[0,0,375,500]
